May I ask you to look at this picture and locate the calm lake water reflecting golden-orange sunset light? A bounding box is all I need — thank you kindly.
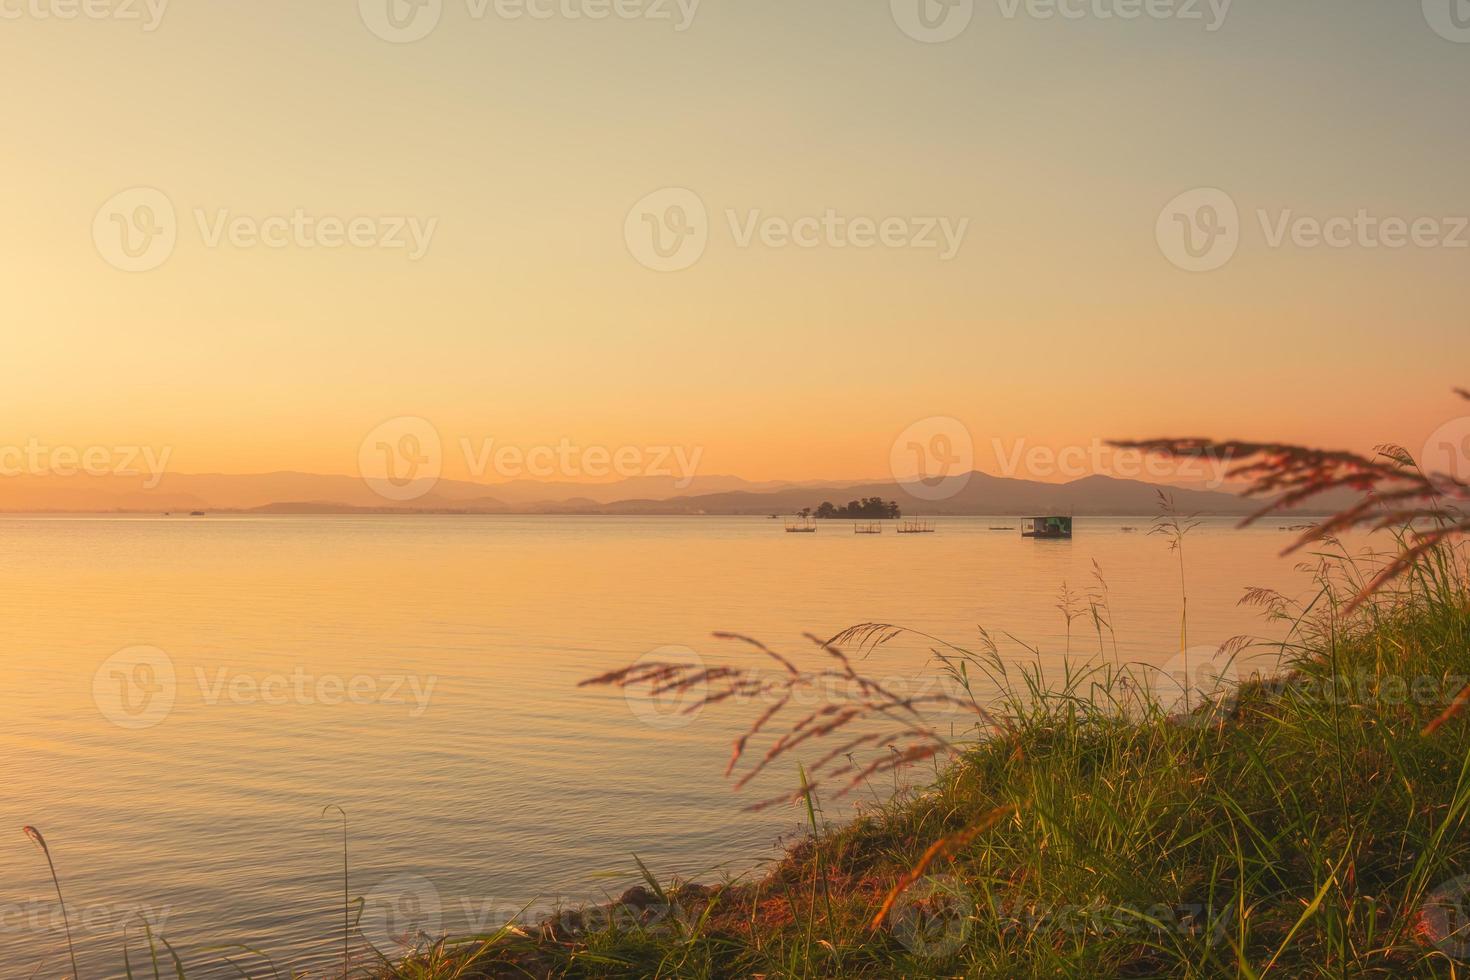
[0,516,1346,977]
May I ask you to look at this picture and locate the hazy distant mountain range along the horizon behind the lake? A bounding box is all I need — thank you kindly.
[0,472,1351,516]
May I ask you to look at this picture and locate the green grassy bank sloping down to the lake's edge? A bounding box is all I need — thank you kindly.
[381,539,1470,977]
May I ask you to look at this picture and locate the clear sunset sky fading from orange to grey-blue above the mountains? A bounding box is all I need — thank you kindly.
[0,0,1470,480]
